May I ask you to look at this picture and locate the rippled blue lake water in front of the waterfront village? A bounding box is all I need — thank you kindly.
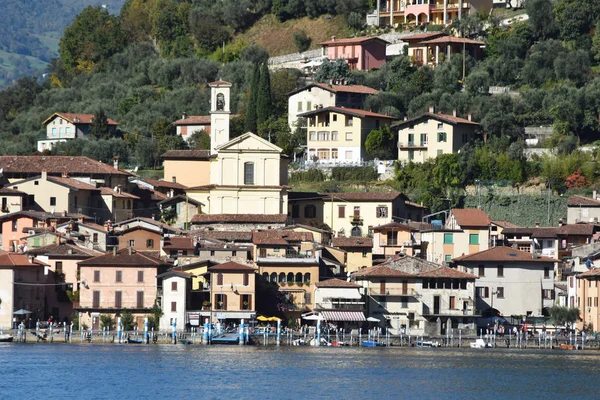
[0,343,600,400]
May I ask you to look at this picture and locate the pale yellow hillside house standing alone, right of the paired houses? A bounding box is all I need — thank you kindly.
[392,107,479,163]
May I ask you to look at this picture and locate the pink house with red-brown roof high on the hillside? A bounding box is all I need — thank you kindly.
[321,36,388,71]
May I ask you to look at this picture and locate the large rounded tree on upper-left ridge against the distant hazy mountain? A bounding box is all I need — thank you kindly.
[58,6,127,72]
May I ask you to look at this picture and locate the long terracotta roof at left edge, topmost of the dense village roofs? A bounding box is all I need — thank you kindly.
[0,156,131,175]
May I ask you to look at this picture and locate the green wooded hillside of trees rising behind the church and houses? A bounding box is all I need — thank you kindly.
[0,0,600,209]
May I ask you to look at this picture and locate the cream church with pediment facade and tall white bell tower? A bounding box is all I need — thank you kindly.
[163,81,289,222]
